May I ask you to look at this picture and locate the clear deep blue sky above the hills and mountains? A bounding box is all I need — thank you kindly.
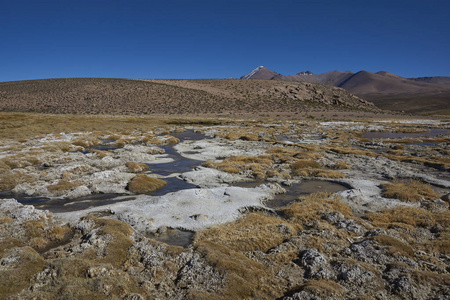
[0,0,450,81]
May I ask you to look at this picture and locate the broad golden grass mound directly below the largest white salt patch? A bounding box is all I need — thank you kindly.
[196,213,293,252]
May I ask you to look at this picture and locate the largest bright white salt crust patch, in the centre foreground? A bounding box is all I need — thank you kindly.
[57,184,281,231]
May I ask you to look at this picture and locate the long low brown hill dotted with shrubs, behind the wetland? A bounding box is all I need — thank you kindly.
[0,78,378,115]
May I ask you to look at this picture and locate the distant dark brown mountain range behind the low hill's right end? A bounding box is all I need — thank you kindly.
[241,68,450,113]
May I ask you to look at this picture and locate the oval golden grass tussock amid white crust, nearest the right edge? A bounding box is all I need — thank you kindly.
[381,180,439,202]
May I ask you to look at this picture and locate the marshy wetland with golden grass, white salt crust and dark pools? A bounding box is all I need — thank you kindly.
[0,113,450,299]
